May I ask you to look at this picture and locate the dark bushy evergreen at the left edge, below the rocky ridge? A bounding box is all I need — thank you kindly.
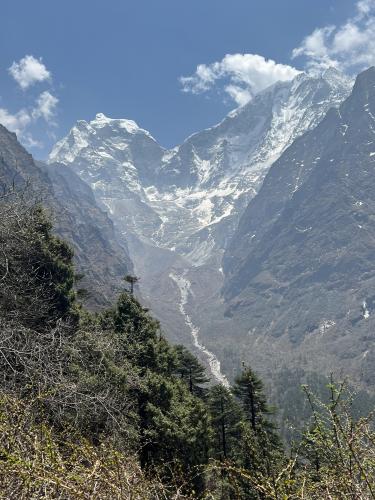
[0,197,76,330]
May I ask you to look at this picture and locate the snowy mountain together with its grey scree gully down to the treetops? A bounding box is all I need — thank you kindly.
[49,70,352,380]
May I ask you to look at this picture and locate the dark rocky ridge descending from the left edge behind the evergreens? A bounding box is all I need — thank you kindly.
[0,125,132,308]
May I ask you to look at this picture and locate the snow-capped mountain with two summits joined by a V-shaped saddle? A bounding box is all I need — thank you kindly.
[49,69,352,265]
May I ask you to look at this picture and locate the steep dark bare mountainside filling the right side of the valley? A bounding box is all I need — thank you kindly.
[224,68,375,386]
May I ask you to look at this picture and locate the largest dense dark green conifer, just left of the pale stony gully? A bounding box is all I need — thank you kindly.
[103,293,210,489]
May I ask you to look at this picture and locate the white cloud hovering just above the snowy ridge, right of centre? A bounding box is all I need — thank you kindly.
[180,54,300,105]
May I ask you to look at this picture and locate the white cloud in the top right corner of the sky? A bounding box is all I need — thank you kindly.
[292,0,375,72]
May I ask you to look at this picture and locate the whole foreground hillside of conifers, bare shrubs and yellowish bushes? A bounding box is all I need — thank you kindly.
[0,180,375,500]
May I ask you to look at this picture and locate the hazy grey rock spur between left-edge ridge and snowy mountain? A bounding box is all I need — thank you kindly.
[42,164,133,308]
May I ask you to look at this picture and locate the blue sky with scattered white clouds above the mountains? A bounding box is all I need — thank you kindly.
[0,0,375,158]
